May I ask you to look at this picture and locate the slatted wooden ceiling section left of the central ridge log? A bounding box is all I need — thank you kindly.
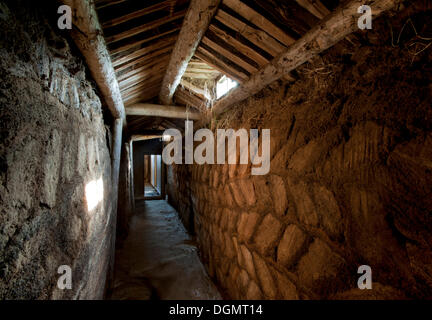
[96,0,189,106]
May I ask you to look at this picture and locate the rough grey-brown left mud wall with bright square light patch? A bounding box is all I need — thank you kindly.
[0,1,112,299]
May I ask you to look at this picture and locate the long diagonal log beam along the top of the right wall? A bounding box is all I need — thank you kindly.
[212,0,398,119]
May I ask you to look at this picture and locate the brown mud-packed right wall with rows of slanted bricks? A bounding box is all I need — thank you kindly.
[168,5,432,299]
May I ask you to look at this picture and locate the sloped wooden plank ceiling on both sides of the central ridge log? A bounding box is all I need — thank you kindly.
[96,0,353,131]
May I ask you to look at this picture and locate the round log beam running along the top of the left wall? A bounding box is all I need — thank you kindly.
[63,0,126,124]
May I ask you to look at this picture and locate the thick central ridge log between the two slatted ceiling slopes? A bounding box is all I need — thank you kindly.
[159,0,220,104]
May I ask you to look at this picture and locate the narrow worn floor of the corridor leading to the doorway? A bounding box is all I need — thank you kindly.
[111,200,221,300]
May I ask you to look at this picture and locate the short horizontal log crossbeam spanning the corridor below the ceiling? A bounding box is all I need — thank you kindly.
[126,103,201,120]
